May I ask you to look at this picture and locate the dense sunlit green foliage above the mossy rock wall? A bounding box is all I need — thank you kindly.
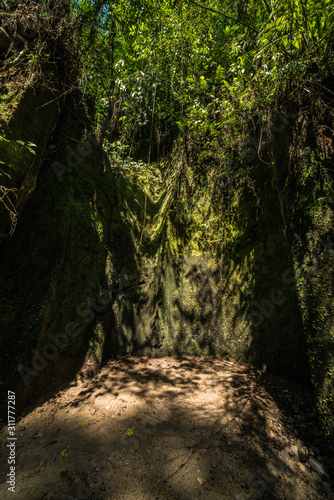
[68,0,334,161]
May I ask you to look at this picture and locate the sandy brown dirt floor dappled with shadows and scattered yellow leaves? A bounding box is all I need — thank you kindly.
[0,357,334,500]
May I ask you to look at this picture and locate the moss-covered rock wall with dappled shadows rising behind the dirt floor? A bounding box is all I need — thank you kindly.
[0,84,333,440]
